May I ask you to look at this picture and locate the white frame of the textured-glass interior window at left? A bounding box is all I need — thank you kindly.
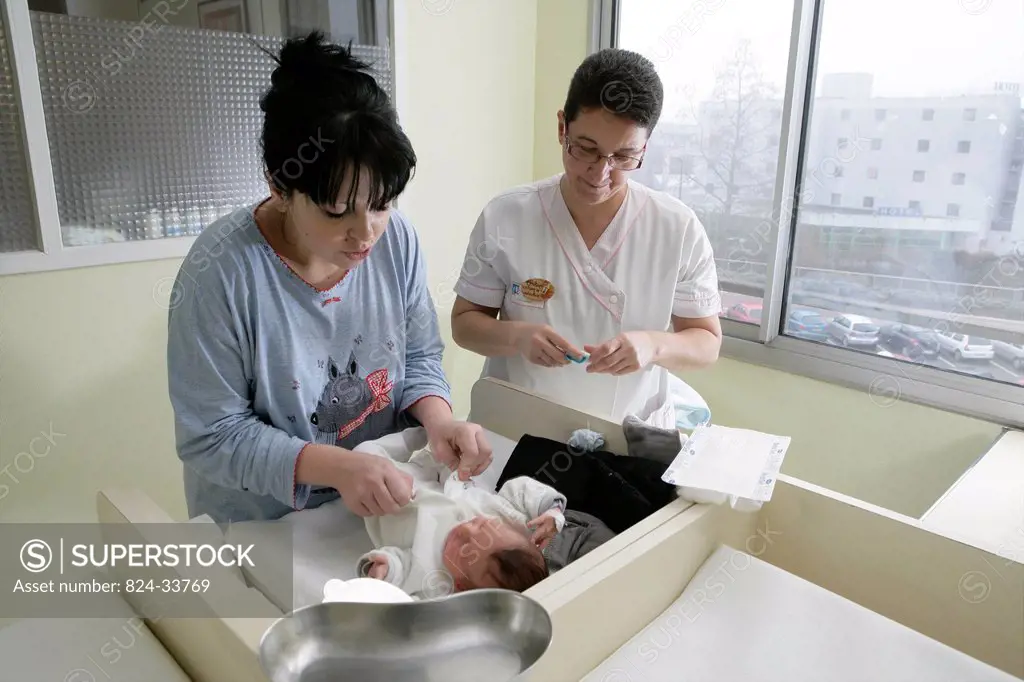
[0,0,398,276]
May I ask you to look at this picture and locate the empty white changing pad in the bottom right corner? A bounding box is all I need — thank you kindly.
[581,547,1020,682]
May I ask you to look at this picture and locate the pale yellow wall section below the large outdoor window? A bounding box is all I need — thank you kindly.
[680,358,1000,518]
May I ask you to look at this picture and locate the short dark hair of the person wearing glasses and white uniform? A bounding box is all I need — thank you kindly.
[563,48,665,134]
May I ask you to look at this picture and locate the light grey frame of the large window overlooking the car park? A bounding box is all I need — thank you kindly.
[589,0,1024,428]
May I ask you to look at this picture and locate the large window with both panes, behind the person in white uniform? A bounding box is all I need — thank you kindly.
[600,0,1024,427]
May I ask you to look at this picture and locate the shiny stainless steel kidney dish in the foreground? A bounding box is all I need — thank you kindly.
[259,590,552,682]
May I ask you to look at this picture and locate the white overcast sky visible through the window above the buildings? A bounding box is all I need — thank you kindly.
[620,0,1024,113]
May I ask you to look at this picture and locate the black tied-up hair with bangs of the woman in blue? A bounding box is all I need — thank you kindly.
[260,31,417,210]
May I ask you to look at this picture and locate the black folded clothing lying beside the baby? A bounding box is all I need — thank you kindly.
[498,434,676,534]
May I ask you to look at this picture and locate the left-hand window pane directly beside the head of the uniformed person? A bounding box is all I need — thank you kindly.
[617,0,794,325]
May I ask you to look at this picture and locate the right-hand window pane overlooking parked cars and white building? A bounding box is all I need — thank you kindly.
[783,0,1024,385]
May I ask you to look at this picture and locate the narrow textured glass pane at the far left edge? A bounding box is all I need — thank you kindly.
[0,12,41,253]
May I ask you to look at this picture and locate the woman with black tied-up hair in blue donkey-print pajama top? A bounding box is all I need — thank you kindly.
[167,34,490,522]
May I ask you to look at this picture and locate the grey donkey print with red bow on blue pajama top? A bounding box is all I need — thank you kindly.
[309,352,394,449]
